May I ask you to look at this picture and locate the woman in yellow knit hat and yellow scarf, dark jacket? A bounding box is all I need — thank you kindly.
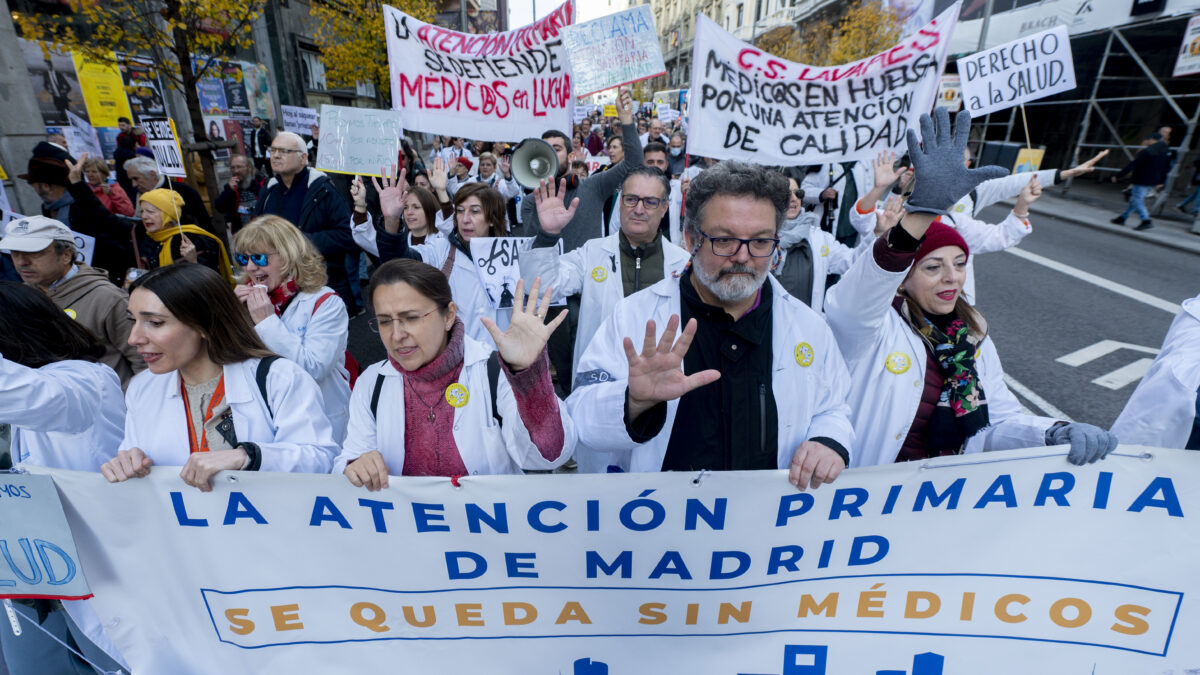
[138,187,234,285]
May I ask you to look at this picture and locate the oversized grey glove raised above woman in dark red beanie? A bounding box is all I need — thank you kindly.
[905,108,1008,215]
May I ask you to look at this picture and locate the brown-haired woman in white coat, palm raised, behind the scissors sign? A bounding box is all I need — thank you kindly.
[354,172,512,344]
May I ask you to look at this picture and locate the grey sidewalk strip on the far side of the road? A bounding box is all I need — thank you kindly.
[1002,180,1200,253]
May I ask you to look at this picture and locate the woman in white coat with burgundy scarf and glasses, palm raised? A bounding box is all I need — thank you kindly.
[334,255,575,482]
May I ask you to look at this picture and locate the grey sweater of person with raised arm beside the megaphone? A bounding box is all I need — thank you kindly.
[520,124,642,252]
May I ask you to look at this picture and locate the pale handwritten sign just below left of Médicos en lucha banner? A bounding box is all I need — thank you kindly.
[317,104,404,178]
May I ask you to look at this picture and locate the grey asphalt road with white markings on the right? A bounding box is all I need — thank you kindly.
[974,207,1200,428]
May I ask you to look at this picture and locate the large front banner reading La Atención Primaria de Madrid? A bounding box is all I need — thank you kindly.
[29,444,1200,675]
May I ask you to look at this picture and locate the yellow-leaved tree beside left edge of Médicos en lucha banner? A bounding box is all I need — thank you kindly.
[310,0,436,92]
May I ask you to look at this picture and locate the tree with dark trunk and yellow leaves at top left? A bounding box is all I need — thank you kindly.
[14,0,266,214]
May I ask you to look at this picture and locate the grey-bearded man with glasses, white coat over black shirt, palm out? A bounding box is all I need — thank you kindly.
[566,161,853,490]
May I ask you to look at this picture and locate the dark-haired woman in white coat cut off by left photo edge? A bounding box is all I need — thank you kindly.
[0,281,125,675]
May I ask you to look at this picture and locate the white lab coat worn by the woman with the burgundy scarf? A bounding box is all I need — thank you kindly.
[332,336,576,476]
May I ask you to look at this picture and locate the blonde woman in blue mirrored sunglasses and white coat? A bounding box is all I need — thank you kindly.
[233,215,358,443]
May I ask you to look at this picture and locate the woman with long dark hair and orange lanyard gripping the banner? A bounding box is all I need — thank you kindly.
[101,263,336,491]
